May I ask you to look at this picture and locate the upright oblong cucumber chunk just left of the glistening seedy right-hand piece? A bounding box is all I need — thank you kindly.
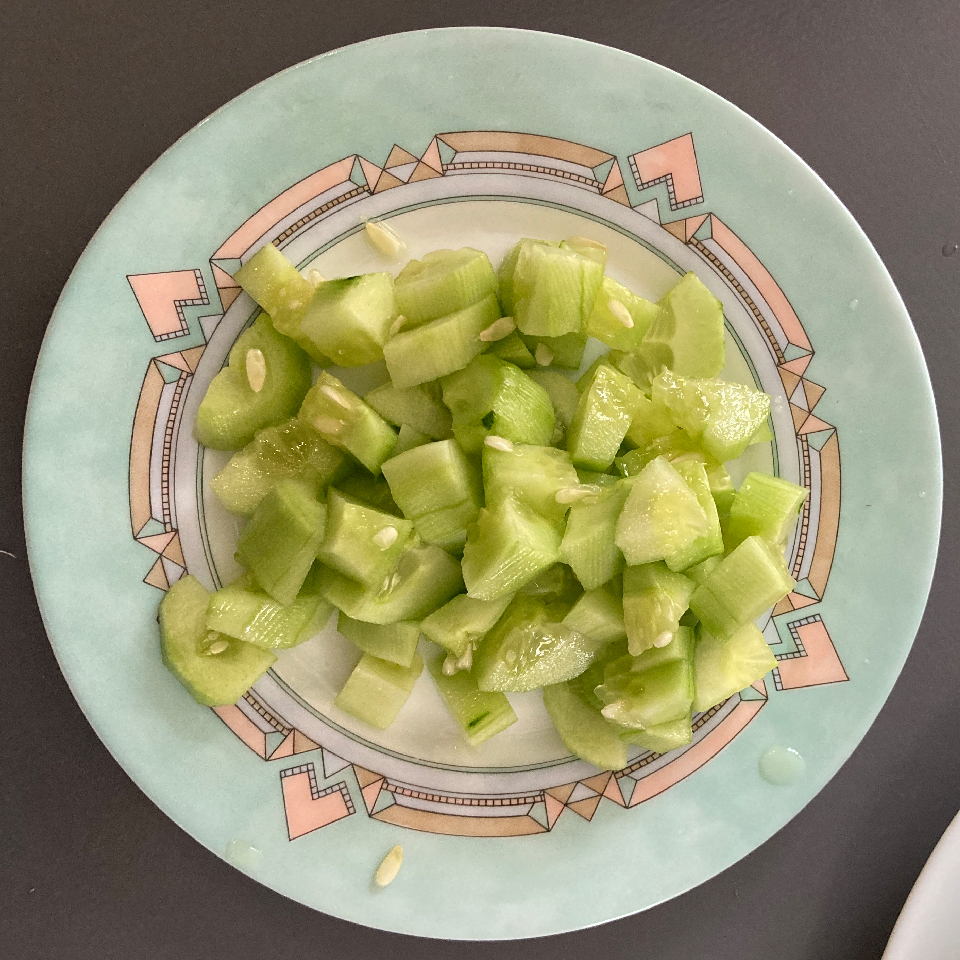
[567,364,640,471]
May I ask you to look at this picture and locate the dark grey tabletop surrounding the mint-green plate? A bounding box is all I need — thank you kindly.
[0,0,960,960]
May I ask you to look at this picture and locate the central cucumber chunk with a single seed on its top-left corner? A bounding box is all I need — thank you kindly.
[483,443,580,523]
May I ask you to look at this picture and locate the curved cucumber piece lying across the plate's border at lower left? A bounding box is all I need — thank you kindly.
[160,576,277,707]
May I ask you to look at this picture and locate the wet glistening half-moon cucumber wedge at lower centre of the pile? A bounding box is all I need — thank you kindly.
[473,594,596,693]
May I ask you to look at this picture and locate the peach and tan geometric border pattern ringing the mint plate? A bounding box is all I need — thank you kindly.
[129,131,848,840]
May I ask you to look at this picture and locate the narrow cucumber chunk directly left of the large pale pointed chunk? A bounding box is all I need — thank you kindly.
[560,478,630,590]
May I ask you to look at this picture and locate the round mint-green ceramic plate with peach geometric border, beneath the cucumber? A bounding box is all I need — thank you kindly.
[25,29,941,939]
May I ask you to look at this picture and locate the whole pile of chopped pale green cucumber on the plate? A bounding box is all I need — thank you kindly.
[160,232,806,770]
